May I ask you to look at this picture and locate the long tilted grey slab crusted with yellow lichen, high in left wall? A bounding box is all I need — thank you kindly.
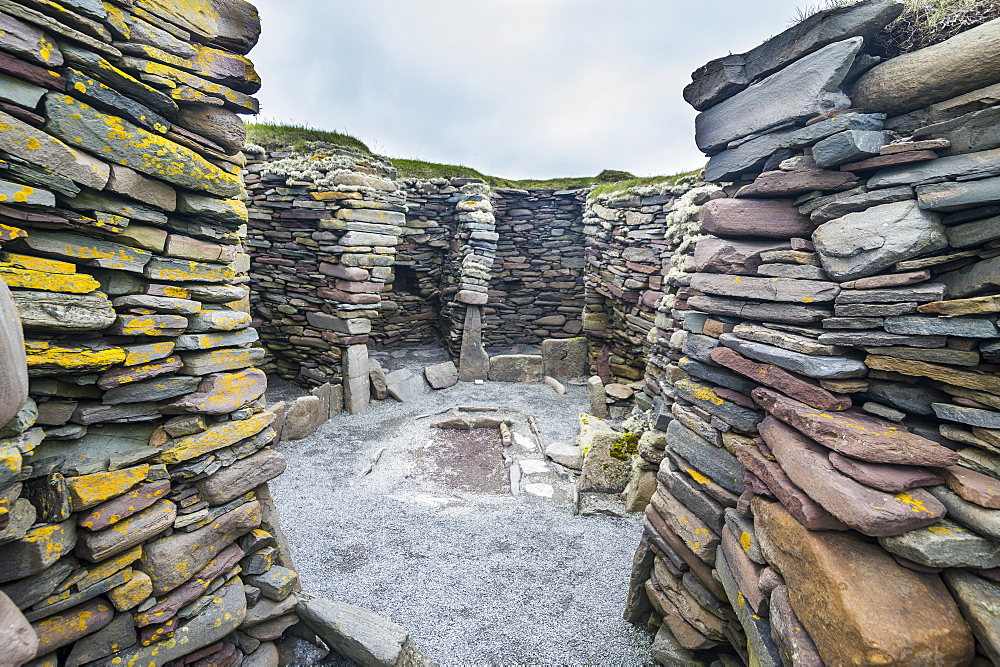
[45,93,240,197]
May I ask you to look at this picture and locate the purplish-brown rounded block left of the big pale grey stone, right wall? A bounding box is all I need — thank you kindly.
[701,199,815,239]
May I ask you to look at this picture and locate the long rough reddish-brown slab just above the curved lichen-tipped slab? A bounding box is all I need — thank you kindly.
[753,388,958,466]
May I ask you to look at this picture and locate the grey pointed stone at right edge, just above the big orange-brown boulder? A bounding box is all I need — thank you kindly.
[879,519,1000,569]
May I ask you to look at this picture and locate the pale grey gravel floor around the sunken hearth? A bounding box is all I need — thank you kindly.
[269,349,652,665]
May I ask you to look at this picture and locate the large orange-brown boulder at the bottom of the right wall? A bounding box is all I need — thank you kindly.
[752,498,975,665]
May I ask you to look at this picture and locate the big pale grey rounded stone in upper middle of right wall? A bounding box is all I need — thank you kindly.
[813,201,948,281]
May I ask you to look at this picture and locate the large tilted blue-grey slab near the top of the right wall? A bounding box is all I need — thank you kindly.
[695,37,864,153]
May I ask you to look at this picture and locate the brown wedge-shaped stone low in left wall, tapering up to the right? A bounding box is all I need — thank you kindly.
[141,501,260,596]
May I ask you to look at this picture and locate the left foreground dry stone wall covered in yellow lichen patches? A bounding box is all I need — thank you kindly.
[0,0,308,665]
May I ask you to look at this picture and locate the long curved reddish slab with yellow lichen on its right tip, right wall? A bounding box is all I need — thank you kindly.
[760,417,946,537]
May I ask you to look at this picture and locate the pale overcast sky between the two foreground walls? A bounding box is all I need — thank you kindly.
[251,0,810,178]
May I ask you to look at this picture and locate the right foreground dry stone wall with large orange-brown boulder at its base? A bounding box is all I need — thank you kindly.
[625,0,1000,665]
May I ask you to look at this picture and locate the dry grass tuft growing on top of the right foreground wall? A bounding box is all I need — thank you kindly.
[792,0,1000,58]
